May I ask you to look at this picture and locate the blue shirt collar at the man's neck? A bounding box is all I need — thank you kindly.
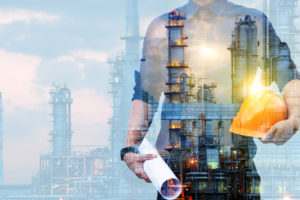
[186,0,228,19]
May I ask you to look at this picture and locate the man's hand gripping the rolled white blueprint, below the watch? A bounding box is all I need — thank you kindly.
[124,152,157,183]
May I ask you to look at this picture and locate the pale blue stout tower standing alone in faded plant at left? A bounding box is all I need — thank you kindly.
[49,85,73,155]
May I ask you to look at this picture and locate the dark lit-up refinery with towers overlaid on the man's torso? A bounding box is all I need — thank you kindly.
[141,11,295,200]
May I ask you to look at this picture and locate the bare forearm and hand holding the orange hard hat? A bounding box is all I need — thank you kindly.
[262,79,300,145]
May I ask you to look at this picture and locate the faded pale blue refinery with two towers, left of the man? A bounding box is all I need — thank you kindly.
[1,0,156,200]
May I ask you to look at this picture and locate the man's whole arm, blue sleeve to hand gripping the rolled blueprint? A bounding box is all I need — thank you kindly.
[124,15,167,182]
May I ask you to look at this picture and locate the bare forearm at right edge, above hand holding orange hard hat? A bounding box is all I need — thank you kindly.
[283,79,300,132]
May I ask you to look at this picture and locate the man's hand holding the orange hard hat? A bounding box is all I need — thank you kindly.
[261,119,295,145]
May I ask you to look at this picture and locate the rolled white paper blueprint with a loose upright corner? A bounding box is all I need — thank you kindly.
[139,93,182,199]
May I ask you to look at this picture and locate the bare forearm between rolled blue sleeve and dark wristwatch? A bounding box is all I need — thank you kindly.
[126,99,148,146]
